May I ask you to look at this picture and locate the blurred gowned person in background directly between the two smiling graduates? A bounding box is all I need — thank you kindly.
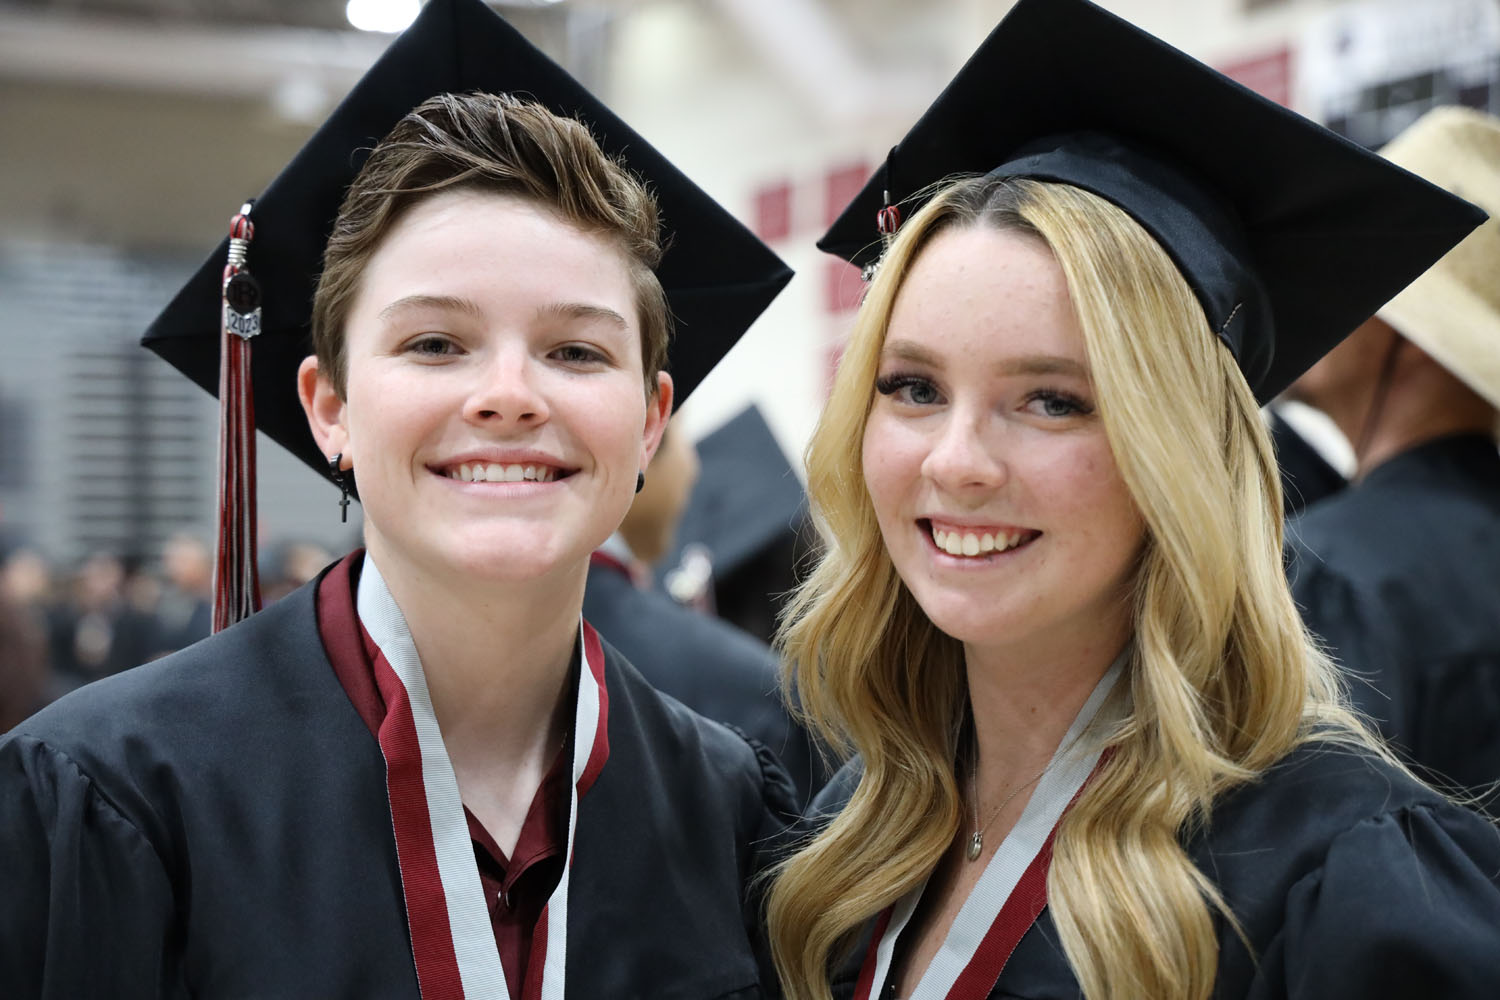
[584,418,825,804]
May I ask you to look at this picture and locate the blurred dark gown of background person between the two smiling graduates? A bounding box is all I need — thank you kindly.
[584,564,827,804]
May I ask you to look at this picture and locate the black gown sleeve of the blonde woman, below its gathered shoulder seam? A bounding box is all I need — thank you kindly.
[1283,805,1500,1000]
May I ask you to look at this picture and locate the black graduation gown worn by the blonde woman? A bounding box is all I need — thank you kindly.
[815,744,1500,1000]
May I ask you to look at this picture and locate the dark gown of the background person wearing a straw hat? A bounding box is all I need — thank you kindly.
[1287,435,1500,813]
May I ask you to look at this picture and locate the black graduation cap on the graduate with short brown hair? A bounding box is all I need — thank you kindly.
[141,0,792,475]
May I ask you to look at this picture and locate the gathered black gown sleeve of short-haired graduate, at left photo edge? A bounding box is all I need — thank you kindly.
[0,735,179,1000]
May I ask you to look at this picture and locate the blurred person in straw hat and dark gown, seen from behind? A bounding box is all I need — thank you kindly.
[1287,106,1500,810]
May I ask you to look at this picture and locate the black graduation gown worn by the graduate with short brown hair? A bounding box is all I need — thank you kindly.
[0,566,792,1000]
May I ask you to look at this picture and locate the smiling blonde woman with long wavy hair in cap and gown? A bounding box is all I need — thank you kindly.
[770,0,1500,1000]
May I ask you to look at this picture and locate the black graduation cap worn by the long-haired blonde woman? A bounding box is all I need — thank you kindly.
[818,0,1485,402]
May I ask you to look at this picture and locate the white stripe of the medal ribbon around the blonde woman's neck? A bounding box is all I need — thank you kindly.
[869,648,1128,1000]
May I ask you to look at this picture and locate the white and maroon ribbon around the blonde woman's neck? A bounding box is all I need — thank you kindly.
[854,654,1125,1000]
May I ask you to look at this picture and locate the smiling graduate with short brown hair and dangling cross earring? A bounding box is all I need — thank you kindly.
[0,0,795,1000]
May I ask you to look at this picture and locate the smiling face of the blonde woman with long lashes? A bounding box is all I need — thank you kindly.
[863,226,1145,665]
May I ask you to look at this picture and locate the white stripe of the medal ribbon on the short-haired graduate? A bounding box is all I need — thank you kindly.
[357,555,605,1000]
